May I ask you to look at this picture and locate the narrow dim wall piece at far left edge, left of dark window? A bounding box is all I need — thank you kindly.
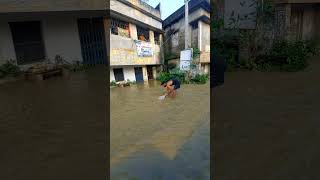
[0,21,16,64]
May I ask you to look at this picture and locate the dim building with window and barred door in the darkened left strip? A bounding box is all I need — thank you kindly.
[0,0,109,67]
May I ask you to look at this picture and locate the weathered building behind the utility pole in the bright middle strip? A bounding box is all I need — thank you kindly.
[163,0,210,73]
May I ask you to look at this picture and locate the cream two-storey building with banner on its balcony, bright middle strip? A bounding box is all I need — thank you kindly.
[109,0,163,82]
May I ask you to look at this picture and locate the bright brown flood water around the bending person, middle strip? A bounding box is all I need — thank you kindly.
[110,81,210,180]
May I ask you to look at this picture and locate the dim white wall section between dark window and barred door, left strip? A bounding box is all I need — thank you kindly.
[43,17,82,62]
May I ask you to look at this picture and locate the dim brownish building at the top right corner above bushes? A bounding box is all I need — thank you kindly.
[276,0,320,40]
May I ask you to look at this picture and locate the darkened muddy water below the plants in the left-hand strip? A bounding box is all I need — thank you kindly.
[0,68,107,180]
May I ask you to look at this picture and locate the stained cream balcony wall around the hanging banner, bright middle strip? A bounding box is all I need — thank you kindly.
[110,34,161,66]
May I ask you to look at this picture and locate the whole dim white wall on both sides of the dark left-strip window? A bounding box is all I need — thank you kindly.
[0,15,82,64]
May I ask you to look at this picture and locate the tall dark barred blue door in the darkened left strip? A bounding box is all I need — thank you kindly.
[78,17,107,65]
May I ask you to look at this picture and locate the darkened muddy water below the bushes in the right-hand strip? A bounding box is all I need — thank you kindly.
[212,58,320,180]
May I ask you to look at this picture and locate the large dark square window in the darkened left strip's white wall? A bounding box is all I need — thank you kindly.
[9,21,45,65]
